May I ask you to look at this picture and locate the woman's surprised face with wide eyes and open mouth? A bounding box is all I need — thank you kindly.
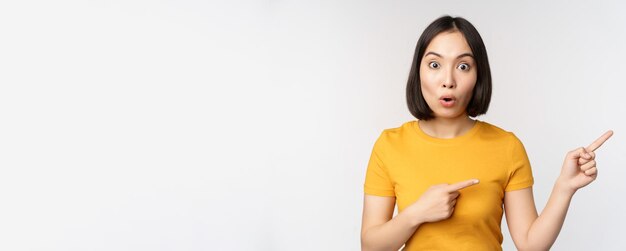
[420,31,477,118]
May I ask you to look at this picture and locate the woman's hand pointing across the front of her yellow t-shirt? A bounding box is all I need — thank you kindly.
[410,179,478,222]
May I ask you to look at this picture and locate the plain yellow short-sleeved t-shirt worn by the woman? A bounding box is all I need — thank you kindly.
[364,120,533,251]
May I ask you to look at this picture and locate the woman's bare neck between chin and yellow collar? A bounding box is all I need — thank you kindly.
[419,116,476,139]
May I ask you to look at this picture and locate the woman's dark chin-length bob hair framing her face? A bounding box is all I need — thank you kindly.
[406,16,491,120]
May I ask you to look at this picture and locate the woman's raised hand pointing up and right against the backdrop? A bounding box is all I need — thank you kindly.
[558,131,613,193]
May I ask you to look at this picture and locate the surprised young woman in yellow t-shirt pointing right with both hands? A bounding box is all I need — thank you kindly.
[361,16,613,250]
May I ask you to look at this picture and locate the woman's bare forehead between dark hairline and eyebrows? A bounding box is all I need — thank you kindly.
[425,30,472,57]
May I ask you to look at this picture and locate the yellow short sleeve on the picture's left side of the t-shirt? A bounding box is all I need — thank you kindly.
[364,136,395,196]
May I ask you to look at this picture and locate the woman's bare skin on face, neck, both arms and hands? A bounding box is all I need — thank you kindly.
[361,31,613,250]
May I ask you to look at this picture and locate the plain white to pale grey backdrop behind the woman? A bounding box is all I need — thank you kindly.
[0,0,626,251]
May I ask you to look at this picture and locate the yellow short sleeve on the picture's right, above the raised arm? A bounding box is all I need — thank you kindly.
[504,133,534,192]
